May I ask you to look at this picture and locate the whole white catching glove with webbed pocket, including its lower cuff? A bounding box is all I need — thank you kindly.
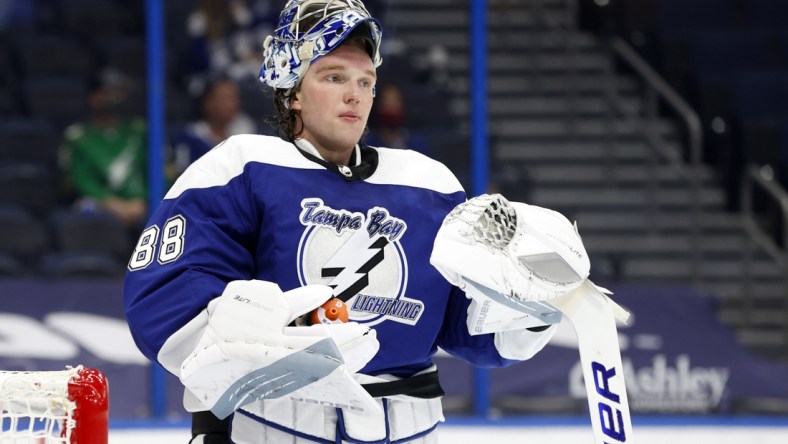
[430,194,591,335]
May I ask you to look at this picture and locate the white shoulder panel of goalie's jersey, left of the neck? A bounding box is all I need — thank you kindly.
[164,134,323,199]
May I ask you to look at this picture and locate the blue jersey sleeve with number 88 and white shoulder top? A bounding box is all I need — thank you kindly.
[123,139,262,360]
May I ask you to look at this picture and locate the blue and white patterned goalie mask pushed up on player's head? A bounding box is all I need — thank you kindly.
[259,0,382,89]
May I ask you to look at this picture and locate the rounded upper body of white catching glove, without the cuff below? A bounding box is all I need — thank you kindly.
[430,194,591,301]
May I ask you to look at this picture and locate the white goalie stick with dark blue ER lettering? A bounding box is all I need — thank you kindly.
[548,280,633,444]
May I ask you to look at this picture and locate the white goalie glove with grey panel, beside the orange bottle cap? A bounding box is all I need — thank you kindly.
[180,281,379,418]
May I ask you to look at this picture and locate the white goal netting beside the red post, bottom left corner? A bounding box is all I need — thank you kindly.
[0,366,82,444]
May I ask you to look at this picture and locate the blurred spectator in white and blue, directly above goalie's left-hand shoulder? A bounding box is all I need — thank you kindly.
[171,76,258,176]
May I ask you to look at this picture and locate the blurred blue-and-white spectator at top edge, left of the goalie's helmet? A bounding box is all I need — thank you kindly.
[186,0,275,96]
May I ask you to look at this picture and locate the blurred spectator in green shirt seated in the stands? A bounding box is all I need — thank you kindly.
[60,68,147,228]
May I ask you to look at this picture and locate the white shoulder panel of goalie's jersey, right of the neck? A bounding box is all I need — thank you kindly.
[367,147,463,194]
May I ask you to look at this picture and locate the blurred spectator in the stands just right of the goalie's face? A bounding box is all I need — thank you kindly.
[366,83,430,155]
